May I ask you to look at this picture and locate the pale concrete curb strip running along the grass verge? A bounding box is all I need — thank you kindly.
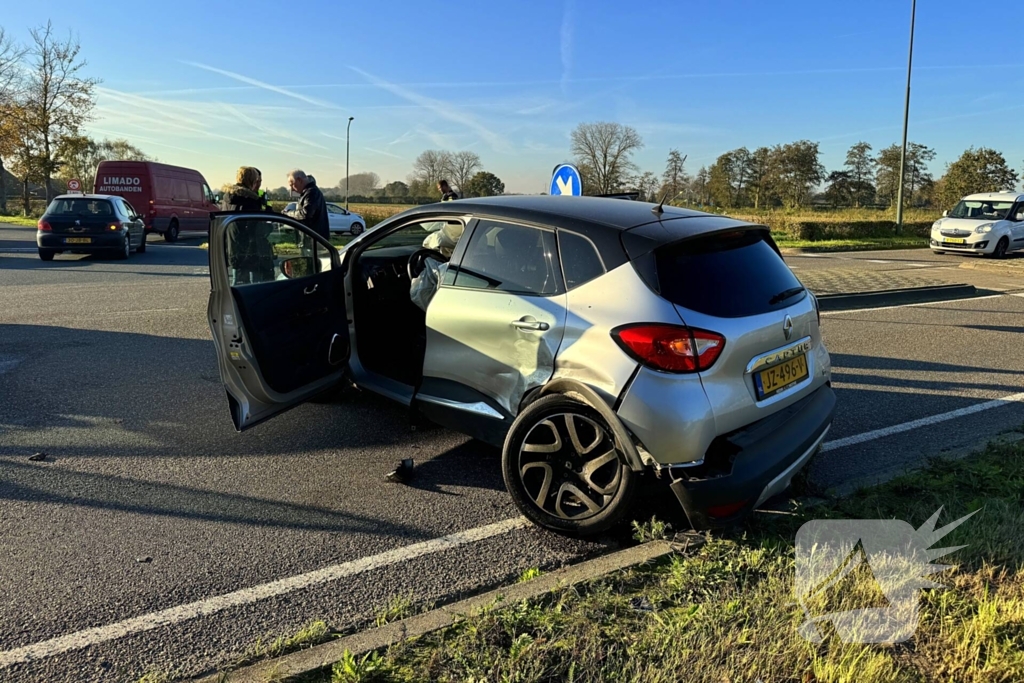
[191,533,705,683]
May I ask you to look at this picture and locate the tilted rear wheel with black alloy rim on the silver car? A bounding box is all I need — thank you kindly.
[502,395,638,537]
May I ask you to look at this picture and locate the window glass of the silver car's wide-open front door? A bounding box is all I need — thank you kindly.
[224,219,331,287]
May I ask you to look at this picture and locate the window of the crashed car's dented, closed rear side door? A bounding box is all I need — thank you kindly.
[455,220,562,296]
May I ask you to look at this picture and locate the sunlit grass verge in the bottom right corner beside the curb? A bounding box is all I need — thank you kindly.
[290,432,1024,683]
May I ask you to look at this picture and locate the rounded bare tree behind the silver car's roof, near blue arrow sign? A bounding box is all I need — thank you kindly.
[571,122,643,195]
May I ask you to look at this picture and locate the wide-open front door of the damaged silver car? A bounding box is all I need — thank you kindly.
[207,213,349,431]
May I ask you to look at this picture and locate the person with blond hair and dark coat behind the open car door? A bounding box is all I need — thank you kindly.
[220,166,274,285]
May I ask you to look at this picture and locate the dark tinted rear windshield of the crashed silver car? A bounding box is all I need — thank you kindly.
[654,230,807,317]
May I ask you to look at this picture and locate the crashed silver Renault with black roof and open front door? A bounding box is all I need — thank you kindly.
[209,196,836,536]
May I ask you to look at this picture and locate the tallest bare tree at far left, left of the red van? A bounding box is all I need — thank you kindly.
[8,23,99,200]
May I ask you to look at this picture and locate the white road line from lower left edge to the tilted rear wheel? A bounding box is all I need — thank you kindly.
[0,517,529,669]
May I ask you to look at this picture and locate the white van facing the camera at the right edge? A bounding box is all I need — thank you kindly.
[930,193,1024,258]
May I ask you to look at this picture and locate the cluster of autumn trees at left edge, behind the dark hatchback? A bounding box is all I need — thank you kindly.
[0,23,150,214]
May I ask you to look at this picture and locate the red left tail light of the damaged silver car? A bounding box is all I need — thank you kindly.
[611,324,725,373]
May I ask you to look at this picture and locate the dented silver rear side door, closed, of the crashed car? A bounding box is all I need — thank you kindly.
[417,218,566,433]
